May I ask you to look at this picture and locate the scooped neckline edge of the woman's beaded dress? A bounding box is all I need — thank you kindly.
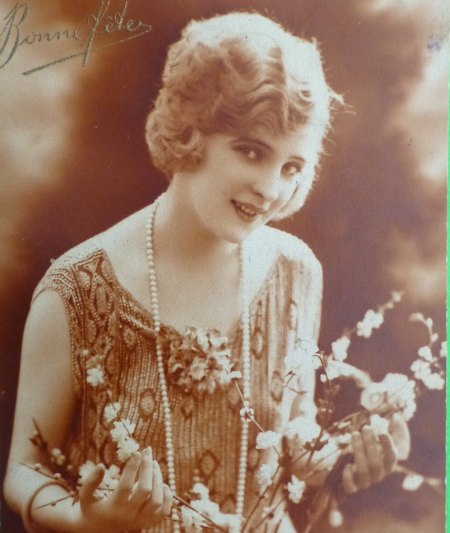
[99,248,282,341]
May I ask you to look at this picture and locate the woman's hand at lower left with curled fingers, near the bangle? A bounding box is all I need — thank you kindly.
[79,447,172,533]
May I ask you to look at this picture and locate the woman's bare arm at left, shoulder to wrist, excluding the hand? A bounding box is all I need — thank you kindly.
[4,291,81,530]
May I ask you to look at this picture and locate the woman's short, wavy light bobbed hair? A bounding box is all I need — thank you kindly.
[146,13,341,216]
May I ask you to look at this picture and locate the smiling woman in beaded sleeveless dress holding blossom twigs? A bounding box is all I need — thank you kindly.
[5,13,408,532]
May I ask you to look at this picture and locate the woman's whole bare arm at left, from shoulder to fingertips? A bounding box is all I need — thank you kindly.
[4,291,172,533]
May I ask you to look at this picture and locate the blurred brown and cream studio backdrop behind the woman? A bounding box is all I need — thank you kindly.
[0,0,449,533]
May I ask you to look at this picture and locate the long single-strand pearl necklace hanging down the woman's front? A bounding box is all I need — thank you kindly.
[145,197,250,533]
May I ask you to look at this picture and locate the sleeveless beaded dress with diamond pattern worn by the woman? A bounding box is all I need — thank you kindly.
[33,229,322,531]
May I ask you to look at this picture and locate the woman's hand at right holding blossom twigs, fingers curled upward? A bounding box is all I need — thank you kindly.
[342,415,410,494]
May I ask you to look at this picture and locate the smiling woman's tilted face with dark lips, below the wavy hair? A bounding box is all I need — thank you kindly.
[174,125,322,243]
